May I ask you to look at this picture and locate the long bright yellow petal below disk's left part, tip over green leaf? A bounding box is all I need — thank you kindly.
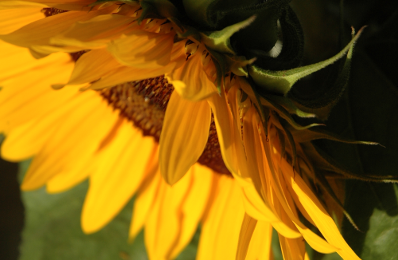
[82,122,154,233]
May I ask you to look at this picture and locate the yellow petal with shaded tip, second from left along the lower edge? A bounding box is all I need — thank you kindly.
[21,93,103,190]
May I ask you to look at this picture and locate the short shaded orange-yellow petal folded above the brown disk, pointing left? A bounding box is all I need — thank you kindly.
[108,30,174,69]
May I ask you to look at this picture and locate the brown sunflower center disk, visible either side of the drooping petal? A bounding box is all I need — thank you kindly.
[101,76,230,175]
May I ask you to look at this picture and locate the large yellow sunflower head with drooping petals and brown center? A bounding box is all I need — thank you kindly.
[0,0,366,259]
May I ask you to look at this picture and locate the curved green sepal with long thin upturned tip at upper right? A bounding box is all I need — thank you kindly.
[249,28,363,95]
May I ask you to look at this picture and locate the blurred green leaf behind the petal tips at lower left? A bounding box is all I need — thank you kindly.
[20,182,147,260]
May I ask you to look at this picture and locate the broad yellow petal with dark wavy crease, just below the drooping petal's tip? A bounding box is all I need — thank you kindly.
[145,165,213,259]
